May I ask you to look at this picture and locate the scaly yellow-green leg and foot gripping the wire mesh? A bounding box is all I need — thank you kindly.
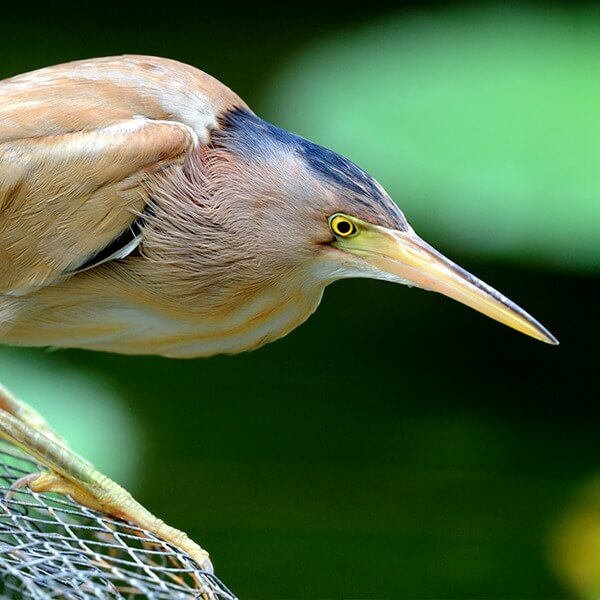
[0,389,213,573]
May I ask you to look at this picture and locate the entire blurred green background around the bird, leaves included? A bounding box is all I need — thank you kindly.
[0,2,600,599]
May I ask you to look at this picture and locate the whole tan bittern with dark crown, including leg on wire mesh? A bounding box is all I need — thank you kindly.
[0,56,557,568]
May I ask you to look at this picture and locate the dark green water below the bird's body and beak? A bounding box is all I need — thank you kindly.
[56,270,598,598]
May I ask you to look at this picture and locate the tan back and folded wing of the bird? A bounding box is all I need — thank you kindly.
[0,56,245,294]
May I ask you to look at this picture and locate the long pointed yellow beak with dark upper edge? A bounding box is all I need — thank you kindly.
[336,224,558,344]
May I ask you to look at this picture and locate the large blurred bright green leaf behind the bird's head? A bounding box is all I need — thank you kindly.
[265,6,600,269]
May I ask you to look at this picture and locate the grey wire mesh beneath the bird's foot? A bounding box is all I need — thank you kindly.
[0,440,235,600]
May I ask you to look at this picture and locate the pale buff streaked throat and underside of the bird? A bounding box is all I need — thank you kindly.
[0,274,323,358]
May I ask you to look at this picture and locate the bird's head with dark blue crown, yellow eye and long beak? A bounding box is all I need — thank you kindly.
[203,109,558,344]
